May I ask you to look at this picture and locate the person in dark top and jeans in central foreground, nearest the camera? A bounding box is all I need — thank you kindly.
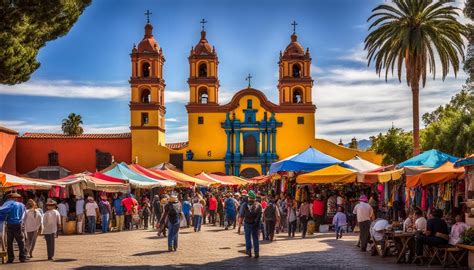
[240,190,262,258]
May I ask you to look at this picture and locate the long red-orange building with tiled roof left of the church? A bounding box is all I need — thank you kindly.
[16,133,132,174]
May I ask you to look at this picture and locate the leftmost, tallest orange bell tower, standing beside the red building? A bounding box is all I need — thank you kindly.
[129,11,166,145]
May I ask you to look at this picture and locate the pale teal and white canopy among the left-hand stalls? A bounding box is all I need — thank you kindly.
[102,162,176,188]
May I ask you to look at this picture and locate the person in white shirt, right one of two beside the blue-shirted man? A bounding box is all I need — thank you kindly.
[43,199,61,260]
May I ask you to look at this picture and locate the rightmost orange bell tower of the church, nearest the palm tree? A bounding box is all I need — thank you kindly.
[278,21,313,105]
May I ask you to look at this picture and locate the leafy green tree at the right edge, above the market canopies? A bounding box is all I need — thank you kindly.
[421,87,474,157]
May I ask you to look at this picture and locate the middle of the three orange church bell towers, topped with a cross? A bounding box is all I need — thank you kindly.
[188,19,219,105]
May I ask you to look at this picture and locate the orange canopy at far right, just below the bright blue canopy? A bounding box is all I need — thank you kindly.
[407,161,464,187]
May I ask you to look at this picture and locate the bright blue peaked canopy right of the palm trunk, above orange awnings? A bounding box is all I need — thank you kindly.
[397,149,459,168]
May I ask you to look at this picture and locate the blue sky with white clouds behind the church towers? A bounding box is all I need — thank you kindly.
[0,0,466,142]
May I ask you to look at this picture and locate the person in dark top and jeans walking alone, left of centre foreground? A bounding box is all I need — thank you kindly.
[160,195,183,251]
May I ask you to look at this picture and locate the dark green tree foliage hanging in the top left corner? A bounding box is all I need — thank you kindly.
[0,0,91,84]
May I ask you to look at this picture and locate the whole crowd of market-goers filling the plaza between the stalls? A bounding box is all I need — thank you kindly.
[0,186,467,262]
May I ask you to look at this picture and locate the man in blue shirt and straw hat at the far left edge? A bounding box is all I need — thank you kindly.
[0,192,26,263]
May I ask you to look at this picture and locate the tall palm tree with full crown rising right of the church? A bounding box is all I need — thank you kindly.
[365,0,466,154]
